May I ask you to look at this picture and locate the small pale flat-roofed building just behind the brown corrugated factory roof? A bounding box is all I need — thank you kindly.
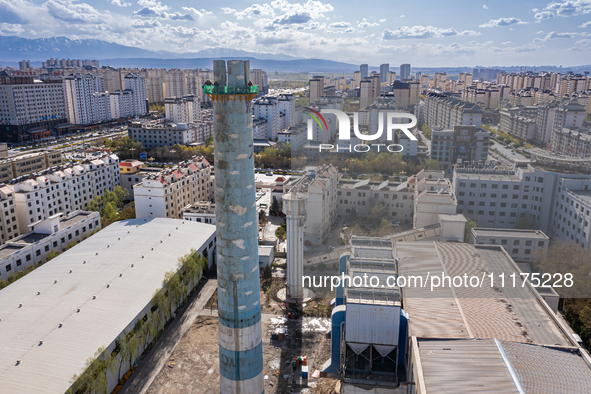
[470,227,550,262]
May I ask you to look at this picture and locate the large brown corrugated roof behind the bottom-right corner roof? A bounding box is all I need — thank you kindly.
[395,242,575,346]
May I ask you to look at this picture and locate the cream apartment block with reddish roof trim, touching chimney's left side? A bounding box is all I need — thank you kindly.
[133,157,214,219]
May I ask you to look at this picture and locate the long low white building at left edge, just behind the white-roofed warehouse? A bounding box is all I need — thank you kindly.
[0,211,101,281]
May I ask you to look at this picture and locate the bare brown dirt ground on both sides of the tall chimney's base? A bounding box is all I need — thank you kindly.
[147,286,337,394]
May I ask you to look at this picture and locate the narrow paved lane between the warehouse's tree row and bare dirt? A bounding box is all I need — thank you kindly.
[119,279,218,394]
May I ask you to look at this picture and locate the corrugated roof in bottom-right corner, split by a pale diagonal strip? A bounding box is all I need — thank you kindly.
[416,339,591,394]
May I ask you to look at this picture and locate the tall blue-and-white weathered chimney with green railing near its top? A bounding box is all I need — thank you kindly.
[203,60,265,394]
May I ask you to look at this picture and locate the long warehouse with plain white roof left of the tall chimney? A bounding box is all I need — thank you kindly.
[0,218,216,394]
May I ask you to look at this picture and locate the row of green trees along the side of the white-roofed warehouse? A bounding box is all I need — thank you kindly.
[69,249,208,394]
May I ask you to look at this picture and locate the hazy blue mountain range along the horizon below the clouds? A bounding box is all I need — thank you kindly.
[0,36,591,74]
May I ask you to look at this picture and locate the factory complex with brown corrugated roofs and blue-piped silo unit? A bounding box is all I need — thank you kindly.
[324,237,591,394]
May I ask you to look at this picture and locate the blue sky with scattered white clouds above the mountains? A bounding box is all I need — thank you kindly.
[0,0,591,67]
